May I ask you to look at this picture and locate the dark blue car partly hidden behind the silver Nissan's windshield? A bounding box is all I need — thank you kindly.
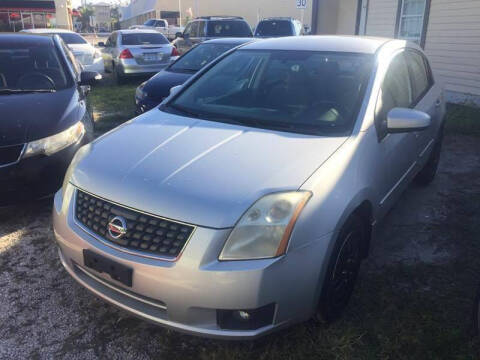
[135,38,252,114]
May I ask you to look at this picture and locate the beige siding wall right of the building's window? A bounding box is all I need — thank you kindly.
[425,0,480,101]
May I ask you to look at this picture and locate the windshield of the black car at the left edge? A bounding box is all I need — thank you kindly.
[0,41,71,95]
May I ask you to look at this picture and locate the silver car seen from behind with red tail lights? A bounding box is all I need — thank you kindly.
[98,30,178,83]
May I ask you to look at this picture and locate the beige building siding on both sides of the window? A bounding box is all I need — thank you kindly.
[358,0,480,104]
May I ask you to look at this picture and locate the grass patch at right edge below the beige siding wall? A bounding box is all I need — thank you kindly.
[445,104,480,136]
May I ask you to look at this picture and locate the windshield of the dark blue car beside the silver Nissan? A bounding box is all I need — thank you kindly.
[170,43,242,72]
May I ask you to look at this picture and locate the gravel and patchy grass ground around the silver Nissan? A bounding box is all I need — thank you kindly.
[0,135,480,359]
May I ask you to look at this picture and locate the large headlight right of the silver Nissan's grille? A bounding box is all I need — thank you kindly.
[219,191,312,260]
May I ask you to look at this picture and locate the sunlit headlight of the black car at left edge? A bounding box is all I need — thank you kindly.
[23,121,85,158]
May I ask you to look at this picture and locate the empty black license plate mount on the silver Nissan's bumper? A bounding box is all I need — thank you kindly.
[83,249,133,287]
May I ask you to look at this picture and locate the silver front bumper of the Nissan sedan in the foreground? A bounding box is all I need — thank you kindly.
[53,185,328,339]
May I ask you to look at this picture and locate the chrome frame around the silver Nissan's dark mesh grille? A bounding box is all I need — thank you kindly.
[72,185,197,262]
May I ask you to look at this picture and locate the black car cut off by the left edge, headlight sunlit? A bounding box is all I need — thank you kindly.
[0,34,101,206]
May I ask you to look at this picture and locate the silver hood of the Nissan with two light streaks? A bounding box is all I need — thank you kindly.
[70,110,346,228]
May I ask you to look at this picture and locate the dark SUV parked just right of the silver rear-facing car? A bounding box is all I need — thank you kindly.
[172,16,253,54]
